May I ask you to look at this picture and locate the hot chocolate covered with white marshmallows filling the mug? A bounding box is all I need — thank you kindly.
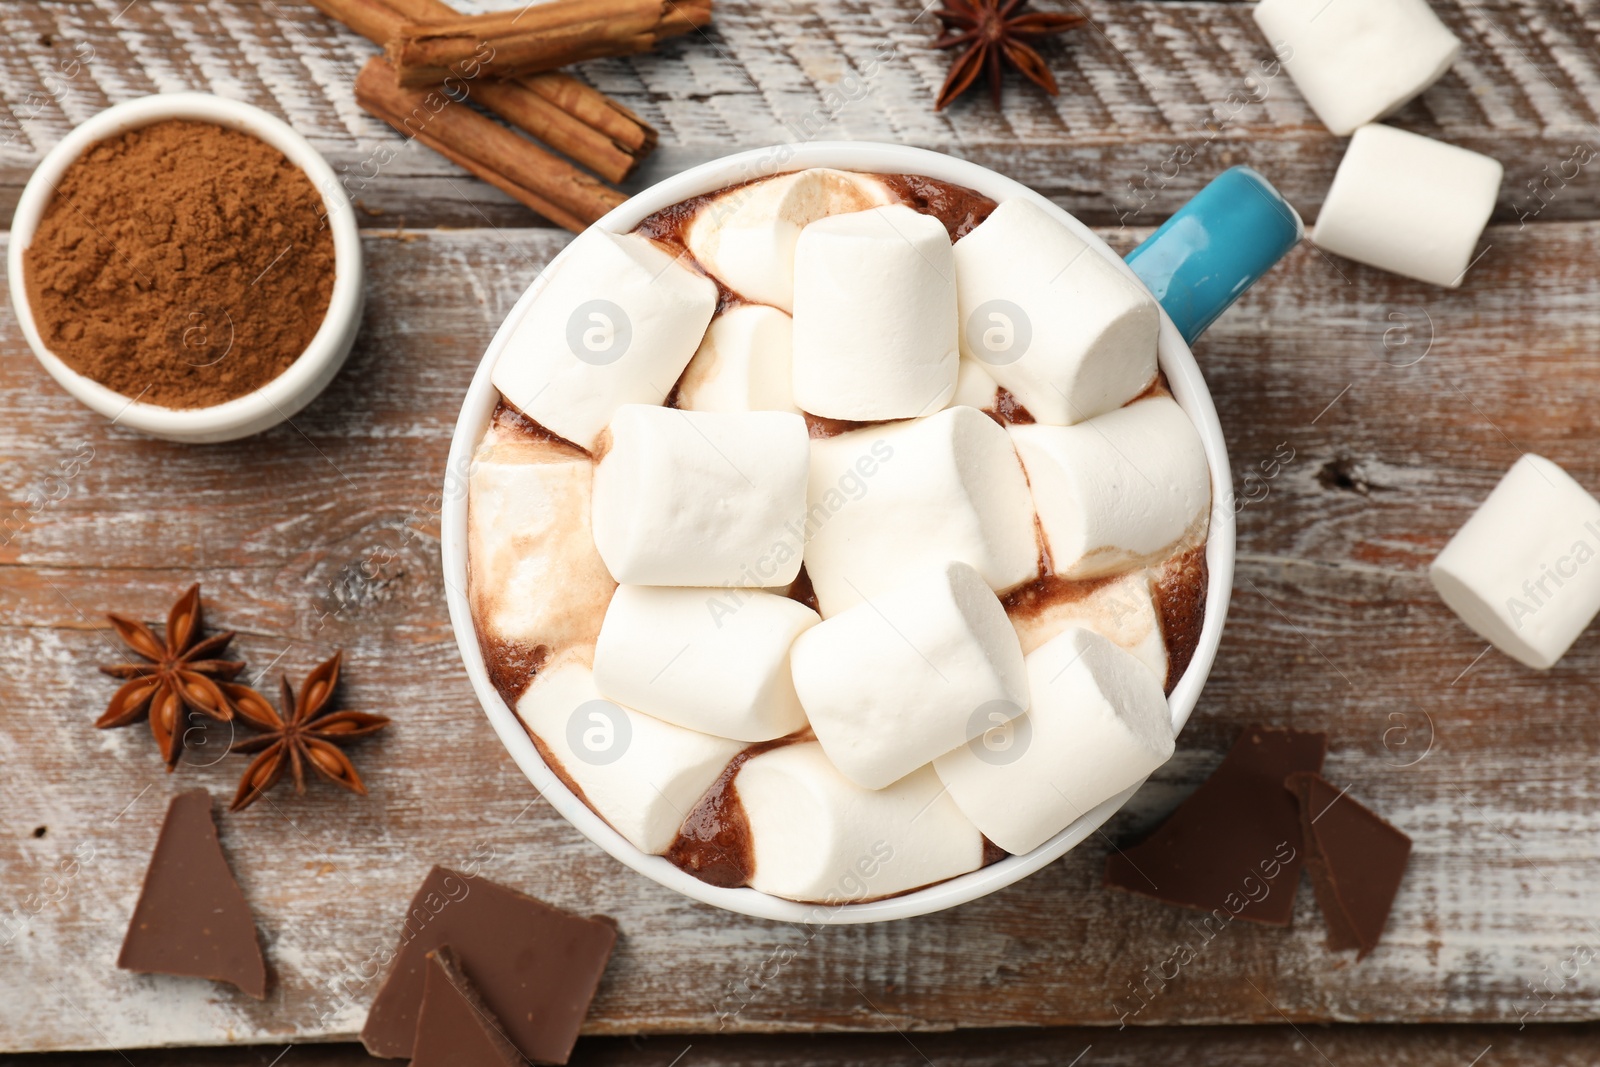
[469,170,1211,902]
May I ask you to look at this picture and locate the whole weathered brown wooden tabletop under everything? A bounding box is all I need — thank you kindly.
[0,0,1600,1064]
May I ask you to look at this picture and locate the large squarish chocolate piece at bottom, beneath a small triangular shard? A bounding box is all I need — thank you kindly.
[362,870,617,1064]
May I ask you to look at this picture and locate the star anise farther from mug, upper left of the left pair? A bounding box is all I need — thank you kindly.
[94,582,254,773]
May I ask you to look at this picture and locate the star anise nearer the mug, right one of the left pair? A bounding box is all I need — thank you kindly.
[229,653,389,811]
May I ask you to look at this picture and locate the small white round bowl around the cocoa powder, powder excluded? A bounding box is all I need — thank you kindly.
[6,93,366,442]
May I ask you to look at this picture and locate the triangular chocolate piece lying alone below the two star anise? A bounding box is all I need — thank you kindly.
[117,789,267,1000]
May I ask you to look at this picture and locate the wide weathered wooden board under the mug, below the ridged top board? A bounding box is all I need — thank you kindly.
[9,222,1600,1059]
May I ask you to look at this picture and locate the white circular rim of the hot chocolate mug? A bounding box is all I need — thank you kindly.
[443,142,1234,923]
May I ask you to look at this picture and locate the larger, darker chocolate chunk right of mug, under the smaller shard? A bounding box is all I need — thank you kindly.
[1106,726,1328,926]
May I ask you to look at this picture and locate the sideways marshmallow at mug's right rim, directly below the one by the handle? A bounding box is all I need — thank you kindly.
[1011,397,1211,577]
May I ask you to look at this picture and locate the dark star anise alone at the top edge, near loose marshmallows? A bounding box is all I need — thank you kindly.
[933,0,1088,110]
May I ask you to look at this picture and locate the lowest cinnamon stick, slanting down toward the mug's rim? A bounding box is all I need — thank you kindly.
[355,56,626,232]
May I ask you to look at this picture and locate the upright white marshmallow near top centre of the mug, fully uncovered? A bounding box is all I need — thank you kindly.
[794,205,957,421]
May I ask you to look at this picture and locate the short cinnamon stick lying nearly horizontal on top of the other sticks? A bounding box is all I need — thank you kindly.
[386,0,712,86]
